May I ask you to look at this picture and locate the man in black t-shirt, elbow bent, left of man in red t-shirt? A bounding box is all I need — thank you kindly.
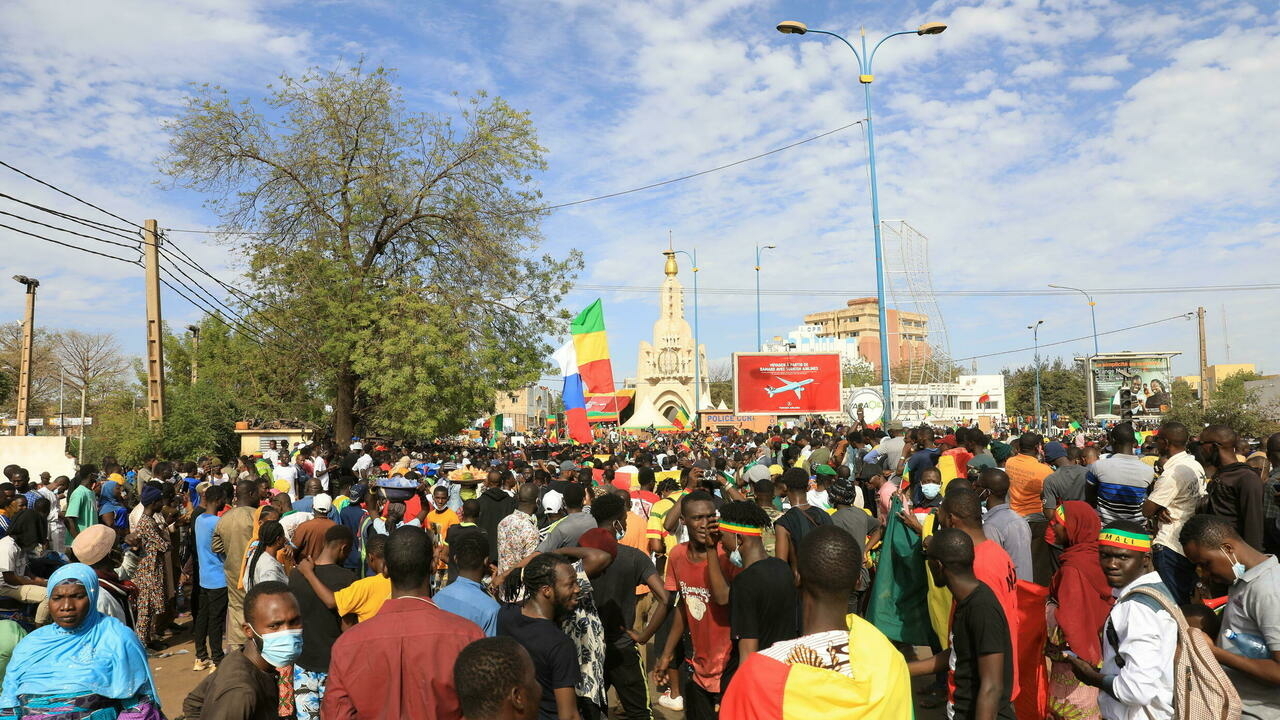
[584,493,669,720]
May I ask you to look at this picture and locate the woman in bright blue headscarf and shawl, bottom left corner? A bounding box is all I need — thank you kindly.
[0,562,164,720]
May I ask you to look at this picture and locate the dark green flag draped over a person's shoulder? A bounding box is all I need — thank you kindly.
[867,497,933,646]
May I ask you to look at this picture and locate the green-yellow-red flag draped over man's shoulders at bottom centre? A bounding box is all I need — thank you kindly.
[719,615,913,720]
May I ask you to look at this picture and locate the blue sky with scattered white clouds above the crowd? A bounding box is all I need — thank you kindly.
[0,0,1280,386]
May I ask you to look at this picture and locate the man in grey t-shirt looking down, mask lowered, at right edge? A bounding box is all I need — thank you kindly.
[1179,515,1280,719]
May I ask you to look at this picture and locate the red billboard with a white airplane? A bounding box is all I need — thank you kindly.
[733,352,844,415]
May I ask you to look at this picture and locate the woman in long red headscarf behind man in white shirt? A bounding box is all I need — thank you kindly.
[1044,500,1114,720]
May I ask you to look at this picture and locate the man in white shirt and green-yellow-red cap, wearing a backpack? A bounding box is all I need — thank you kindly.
[1068,520,1178,720]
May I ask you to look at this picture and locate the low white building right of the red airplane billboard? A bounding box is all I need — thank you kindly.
[845,374,1005,425]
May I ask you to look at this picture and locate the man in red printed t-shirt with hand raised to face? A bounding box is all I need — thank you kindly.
[654,491,733,720]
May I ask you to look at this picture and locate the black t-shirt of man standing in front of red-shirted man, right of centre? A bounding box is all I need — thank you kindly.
[948,583,1015,720]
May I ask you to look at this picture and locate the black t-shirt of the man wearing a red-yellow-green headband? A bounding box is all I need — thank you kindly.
[721,557,800,687]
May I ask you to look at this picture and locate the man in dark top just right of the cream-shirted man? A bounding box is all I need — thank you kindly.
[1196,425,1266,552]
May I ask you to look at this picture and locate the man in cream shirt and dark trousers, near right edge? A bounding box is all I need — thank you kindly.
[1142,421,1204,605]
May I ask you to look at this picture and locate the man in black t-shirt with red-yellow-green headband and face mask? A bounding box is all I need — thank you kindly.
[719,501,798,687]
